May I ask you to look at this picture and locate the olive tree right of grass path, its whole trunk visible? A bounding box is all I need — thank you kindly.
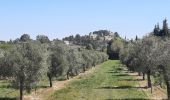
[120,36,157,87]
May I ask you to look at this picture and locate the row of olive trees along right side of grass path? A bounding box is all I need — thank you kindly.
[120,35,170,99]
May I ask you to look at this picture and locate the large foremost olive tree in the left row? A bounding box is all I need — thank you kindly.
[4,43,42,100]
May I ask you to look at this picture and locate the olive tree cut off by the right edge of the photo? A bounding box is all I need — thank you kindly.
[153,39,170,100]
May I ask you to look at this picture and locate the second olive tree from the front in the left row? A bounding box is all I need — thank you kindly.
[47,42,68,87]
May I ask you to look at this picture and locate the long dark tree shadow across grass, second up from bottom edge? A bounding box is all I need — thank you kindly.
[97,86,148,89]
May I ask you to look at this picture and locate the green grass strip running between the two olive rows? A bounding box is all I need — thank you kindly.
[49,60,147,100]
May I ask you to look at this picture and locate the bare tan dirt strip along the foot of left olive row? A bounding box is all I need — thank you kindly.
[24,66,100,100]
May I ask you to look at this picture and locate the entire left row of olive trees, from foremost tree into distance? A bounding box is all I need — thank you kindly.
[0,34,108,100]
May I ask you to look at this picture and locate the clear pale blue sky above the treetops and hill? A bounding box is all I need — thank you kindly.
[0,0,170,40]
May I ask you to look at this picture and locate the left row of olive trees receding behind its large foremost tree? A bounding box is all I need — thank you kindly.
[47,41,108,87]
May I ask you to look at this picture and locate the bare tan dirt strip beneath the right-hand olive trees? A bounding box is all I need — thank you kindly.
[129,73,167,100]
